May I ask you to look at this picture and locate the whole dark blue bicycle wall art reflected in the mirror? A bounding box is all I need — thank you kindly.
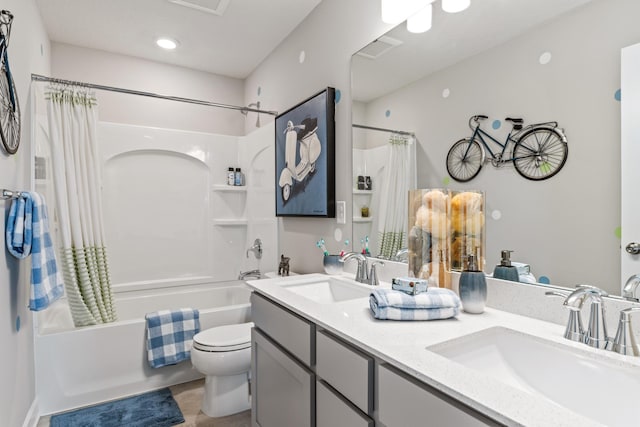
[447,115,569,182]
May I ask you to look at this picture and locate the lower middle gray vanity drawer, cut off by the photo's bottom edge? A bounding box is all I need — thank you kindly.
[316,381,373,427]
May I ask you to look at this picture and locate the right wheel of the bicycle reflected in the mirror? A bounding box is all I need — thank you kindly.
[513,128,569,181]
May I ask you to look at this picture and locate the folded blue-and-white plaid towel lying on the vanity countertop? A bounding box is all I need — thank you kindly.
[369,288,460,320]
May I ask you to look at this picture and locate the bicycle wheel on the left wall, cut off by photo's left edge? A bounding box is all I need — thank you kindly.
[0,57,20,154]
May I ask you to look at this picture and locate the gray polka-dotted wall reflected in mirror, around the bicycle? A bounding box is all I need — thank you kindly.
[367,0,640,294]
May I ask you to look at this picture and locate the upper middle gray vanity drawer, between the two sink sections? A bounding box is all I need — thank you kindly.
[316,331,374,414]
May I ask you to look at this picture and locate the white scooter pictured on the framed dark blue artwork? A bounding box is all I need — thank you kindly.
[279,117,322,203]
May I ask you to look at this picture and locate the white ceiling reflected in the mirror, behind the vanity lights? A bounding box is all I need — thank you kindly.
[352,0,592,102]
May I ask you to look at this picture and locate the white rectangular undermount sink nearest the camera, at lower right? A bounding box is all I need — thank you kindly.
[427,327,640,426]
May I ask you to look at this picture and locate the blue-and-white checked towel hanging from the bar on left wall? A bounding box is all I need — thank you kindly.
[5,192,64,311]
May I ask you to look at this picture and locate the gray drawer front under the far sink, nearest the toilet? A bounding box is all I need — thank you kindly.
[251,292,315,366]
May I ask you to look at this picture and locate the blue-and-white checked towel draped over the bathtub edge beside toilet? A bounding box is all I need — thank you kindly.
[145,308,200,368]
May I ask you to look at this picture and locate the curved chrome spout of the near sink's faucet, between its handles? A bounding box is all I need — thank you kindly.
[563,285,611,348]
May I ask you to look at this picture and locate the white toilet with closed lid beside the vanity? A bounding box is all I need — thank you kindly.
[191,322,253,417]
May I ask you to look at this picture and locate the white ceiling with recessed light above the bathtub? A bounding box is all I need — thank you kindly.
[36,0,321,79]
